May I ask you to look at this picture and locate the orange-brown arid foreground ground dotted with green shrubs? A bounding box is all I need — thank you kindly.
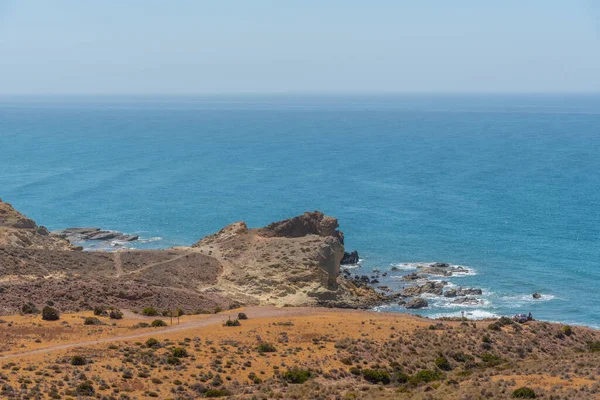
[0,307,600,399]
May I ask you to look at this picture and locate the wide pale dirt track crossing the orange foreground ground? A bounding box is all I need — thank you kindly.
[0,307,324,360]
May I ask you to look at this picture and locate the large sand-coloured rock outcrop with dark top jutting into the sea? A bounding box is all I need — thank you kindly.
[192,211,379,307]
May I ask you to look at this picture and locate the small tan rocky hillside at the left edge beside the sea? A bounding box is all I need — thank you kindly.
[0,199,74,250]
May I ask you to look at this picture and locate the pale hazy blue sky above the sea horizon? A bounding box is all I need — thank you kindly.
[0,0,600,94]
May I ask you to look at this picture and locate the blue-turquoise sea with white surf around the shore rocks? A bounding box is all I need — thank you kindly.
[0,95,600,327]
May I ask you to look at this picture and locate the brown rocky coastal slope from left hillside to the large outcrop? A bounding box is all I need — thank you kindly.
[0,203,388,314]
